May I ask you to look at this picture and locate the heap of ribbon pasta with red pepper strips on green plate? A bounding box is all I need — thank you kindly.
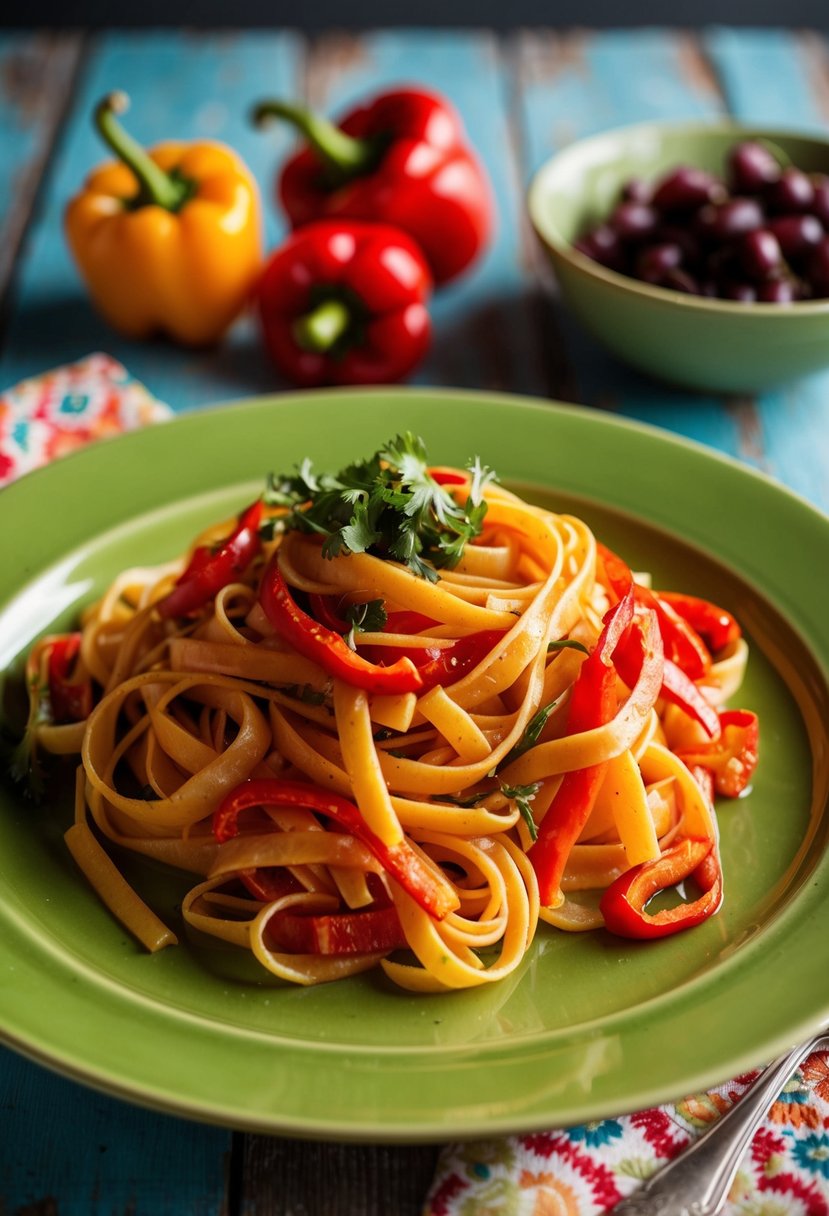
[17,445,756,992]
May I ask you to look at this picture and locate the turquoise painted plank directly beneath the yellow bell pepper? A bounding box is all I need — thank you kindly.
[0,32,303,410]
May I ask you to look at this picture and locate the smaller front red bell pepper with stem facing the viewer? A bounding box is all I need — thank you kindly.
[258,220,432,388]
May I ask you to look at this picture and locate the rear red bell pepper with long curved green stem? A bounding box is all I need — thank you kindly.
[254,89,495,283]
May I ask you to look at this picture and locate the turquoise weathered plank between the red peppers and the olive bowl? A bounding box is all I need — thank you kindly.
[300,29,546,393]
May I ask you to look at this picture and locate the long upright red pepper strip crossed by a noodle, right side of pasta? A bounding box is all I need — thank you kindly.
[528,591,633,906]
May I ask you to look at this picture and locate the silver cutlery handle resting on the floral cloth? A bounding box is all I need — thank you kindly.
[613,1034,829,1216]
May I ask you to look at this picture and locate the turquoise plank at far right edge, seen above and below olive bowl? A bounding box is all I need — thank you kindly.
[706,29,829,511]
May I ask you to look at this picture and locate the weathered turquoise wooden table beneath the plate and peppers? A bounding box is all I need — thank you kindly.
[0,28,829,1216]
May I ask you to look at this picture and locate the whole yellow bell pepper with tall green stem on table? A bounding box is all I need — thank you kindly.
[64,92,263,347]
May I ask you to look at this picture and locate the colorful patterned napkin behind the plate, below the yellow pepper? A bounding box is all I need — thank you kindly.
[0,354,173,486]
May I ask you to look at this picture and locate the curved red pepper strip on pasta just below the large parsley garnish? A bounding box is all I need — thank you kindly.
[259,554,423,693]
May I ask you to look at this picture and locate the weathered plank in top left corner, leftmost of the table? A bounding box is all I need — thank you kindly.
[0,33,83,323]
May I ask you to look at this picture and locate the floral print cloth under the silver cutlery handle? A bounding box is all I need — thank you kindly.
[423,1052,829,1216]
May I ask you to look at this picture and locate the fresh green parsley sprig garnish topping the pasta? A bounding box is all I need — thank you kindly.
[265,432,495,582]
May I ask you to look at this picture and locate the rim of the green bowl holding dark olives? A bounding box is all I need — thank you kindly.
[526,117,829,320]
